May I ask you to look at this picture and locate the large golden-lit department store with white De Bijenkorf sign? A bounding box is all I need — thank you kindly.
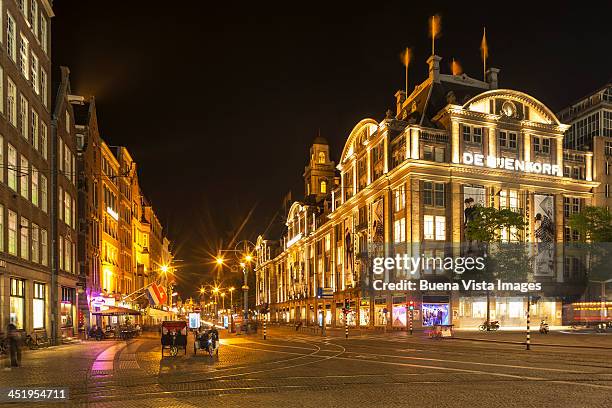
[256,55,599,328]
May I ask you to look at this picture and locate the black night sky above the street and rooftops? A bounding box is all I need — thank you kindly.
[52,0,612,291]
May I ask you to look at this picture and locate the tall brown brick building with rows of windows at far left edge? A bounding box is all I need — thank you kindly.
[0,0,58,336]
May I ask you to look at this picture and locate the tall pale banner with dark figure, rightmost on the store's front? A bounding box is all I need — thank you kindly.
[533,194,555,276]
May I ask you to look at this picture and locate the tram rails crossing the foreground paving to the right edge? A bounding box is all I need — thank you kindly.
[63,336,612,403]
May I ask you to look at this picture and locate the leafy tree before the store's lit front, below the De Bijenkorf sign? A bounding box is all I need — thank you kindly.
[465,206,531,330]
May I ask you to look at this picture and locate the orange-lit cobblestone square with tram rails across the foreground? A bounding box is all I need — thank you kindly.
[0,328,612,408]
